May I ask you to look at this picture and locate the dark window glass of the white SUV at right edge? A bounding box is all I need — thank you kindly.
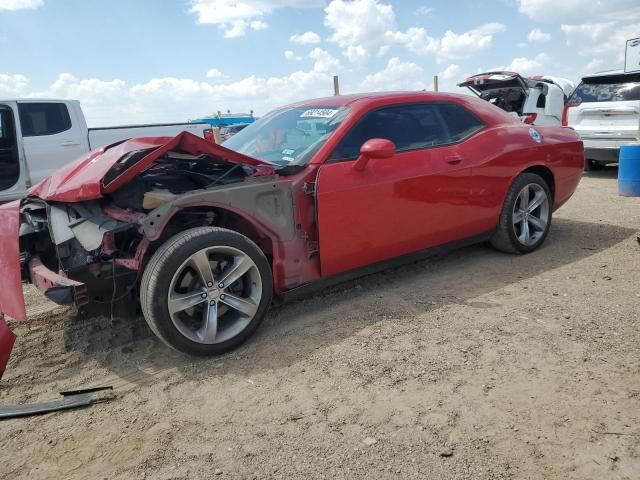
[569,75,640,104]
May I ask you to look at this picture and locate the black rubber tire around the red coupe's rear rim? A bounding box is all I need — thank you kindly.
[490,173,553,253]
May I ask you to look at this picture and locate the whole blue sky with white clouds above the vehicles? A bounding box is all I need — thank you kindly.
[0,0,640,126]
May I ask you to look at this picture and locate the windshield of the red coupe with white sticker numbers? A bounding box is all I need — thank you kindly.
[224,106,349,165]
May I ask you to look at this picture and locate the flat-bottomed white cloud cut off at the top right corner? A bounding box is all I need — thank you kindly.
[518,0,640,25]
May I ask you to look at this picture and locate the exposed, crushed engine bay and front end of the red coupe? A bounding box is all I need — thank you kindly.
[20,150,272,315]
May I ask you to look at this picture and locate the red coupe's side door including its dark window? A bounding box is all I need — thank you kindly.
[316,104,480,276]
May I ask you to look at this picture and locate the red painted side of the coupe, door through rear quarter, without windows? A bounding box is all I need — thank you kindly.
[313,93,583,277]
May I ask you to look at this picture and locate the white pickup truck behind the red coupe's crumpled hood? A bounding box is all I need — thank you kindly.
[0,99,213,202]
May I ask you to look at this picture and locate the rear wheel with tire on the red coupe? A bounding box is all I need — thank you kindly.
[491,173,552,253]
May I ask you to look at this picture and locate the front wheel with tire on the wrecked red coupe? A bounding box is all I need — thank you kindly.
[140,227,273,355]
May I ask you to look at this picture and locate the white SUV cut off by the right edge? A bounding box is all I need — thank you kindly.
[562,70,640,170]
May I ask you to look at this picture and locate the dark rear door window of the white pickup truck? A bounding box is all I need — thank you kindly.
[18,103,71,137]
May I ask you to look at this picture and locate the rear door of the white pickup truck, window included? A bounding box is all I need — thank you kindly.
[18,101,87,184]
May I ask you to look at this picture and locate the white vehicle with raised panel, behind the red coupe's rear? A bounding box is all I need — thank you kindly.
[458,72,575,125]
